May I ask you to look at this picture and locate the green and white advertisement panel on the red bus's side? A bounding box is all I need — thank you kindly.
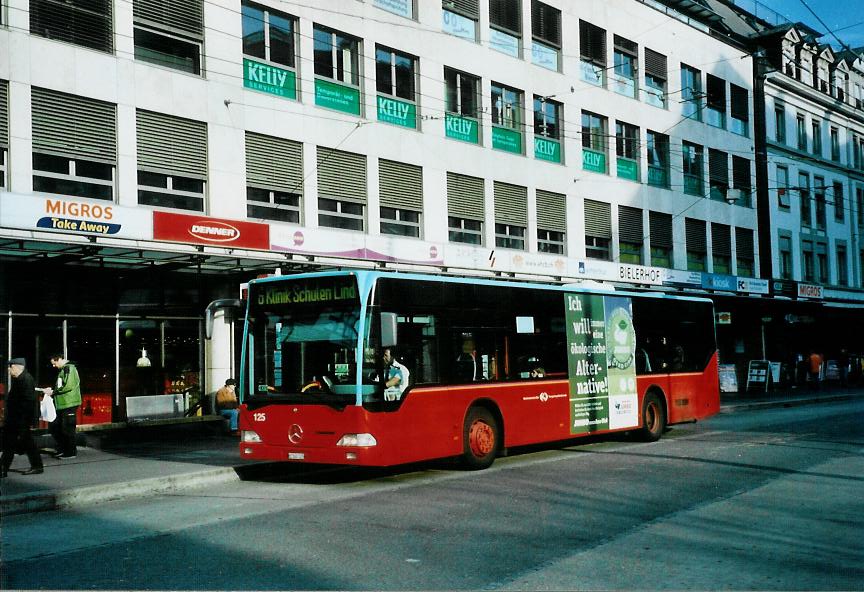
[565,294,639,434]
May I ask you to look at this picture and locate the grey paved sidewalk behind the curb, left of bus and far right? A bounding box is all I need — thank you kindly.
[0,388,864,516]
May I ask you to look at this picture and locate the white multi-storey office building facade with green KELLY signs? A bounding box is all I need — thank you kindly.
[0,0,824,419]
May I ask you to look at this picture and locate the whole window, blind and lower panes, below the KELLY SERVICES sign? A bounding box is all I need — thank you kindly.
[246,132,303,224]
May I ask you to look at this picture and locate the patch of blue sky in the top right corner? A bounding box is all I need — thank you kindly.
[735,0,864,47]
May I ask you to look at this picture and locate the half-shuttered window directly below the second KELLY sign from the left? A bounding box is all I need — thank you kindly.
[378,158,423,238]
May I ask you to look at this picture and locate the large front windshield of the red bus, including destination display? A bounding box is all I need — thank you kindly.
[247,276,360,405]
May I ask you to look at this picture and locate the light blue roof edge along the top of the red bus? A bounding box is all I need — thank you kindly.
[249,269,713,303]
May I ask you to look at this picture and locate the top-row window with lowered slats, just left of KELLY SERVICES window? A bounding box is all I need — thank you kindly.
[133,0,204,75]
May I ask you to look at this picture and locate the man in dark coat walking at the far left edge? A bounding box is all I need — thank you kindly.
[0,358,43,477]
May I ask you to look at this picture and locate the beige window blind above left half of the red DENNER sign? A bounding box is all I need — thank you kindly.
[136,109,207,179]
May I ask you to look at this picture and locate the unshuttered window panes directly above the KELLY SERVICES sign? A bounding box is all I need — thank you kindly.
[241,0,297,68]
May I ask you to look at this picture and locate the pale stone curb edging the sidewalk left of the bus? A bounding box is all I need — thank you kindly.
[0,467,240,516]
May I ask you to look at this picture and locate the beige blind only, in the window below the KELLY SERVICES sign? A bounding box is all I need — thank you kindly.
[246,132,303,195]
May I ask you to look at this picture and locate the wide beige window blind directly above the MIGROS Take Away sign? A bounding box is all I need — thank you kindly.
[31,86,117,164]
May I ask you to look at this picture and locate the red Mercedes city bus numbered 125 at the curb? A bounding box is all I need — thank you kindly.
[239,271,720,469]
